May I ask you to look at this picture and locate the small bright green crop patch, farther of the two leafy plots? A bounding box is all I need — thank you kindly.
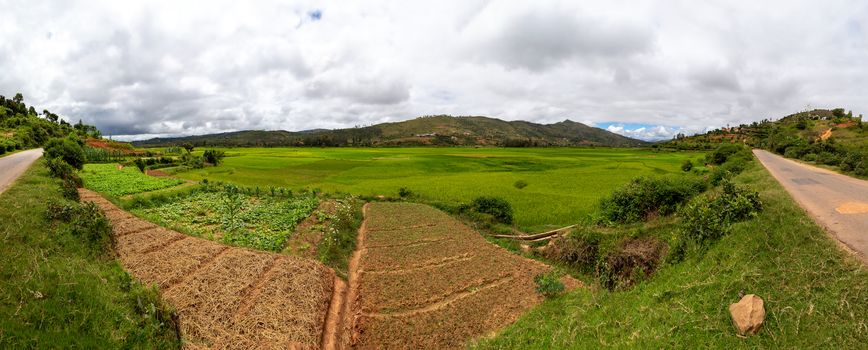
[79,164,183,197]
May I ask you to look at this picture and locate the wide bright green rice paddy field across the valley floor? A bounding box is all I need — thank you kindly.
[176,148,703,231]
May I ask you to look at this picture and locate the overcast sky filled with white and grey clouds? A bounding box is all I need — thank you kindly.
[0,0,868,139]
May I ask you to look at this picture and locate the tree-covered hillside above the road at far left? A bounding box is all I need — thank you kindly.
[0,93,101,154]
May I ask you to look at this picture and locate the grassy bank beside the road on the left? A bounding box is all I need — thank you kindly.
[0,161,180,349]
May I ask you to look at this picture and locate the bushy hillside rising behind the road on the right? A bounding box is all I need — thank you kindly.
[655,108,868,177]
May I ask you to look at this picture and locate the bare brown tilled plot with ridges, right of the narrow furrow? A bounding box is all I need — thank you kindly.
[348,203,576,349]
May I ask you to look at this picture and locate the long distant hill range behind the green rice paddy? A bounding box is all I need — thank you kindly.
[133,115,648,147]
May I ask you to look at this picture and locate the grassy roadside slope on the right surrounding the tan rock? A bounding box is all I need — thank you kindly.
[474,162,868,349]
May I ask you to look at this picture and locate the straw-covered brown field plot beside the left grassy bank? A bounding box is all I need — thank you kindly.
[81,190,342,349]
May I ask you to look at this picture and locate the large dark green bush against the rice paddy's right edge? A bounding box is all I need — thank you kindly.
[599,176,707,223]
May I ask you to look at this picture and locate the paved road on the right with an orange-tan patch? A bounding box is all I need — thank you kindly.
[753,150,868,262]
